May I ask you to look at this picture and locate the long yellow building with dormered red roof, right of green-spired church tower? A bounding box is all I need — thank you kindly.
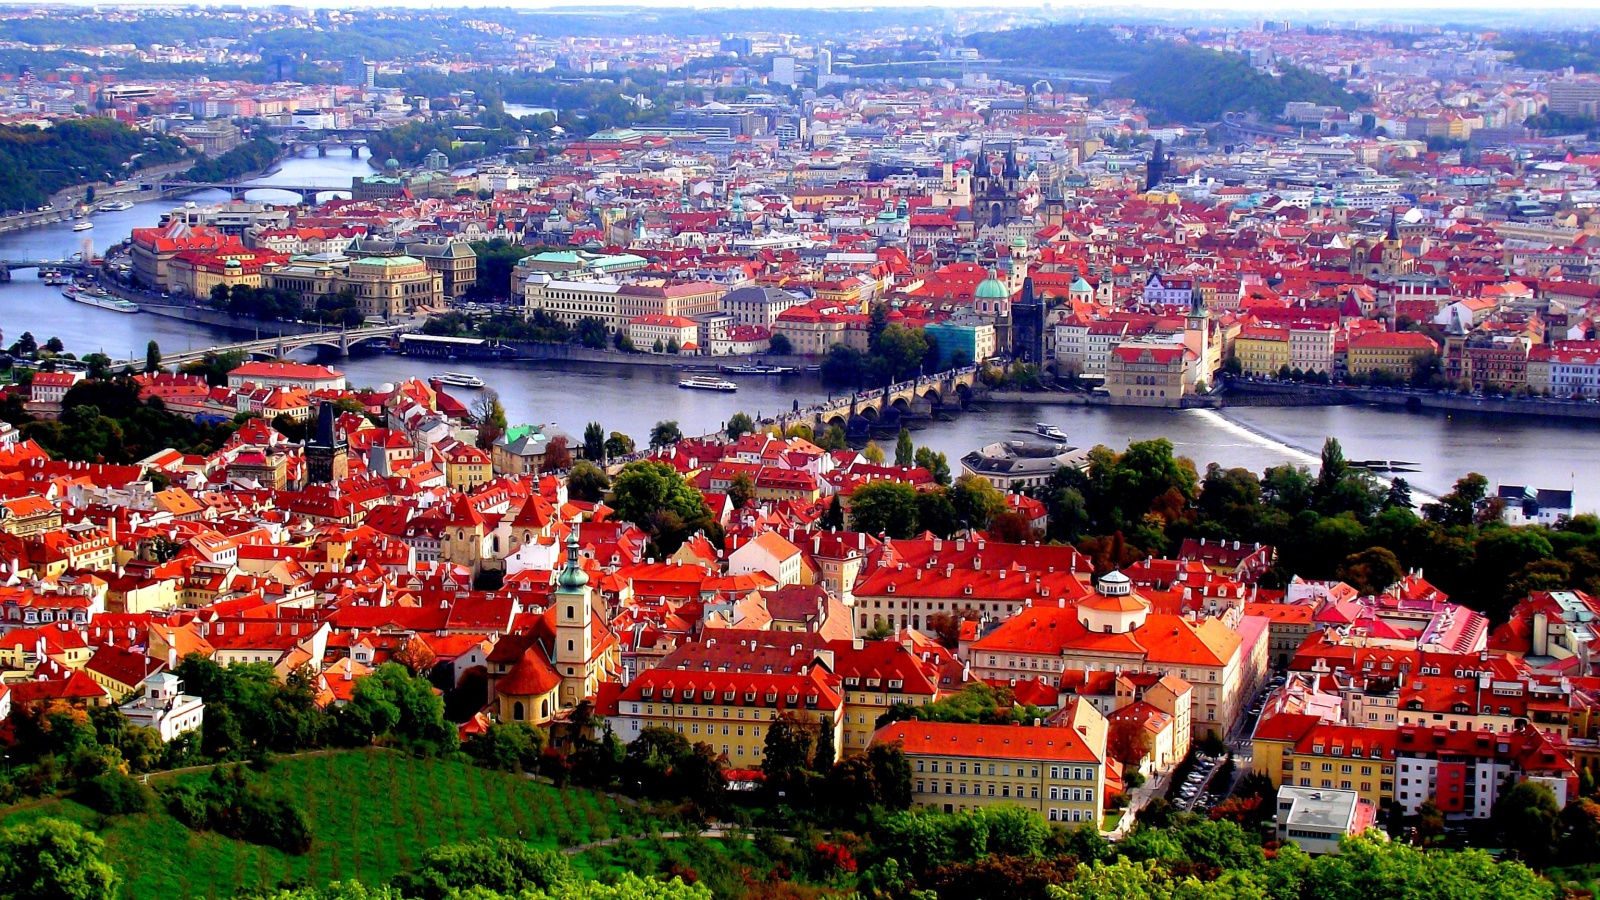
[611,665,845,769]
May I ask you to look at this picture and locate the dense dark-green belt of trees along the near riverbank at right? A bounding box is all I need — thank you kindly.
[1037,439,1600,618]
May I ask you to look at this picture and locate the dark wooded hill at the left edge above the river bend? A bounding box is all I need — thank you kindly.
[0,119,184,211]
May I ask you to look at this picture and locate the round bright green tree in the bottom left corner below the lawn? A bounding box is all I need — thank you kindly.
[0,818,118,900]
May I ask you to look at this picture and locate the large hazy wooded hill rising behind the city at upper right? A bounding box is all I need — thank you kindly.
[968,26,1357,122]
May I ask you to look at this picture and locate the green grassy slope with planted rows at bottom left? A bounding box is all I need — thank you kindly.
[0,751,629,900]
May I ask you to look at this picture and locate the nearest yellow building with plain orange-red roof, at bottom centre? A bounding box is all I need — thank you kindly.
[872,705,1106,826]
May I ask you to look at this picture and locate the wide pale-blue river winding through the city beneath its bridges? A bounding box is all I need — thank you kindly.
[0,151,1600,511]
